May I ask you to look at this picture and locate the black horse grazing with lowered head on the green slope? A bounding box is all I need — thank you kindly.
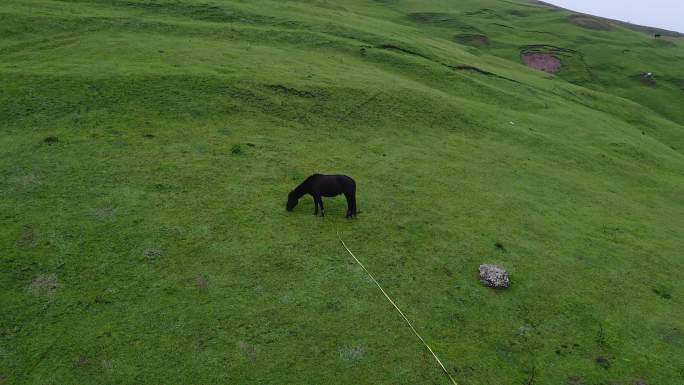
[285,174,356,218]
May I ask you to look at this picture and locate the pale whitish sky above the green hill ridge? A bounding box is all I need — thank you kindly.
[546,0,684,33]
